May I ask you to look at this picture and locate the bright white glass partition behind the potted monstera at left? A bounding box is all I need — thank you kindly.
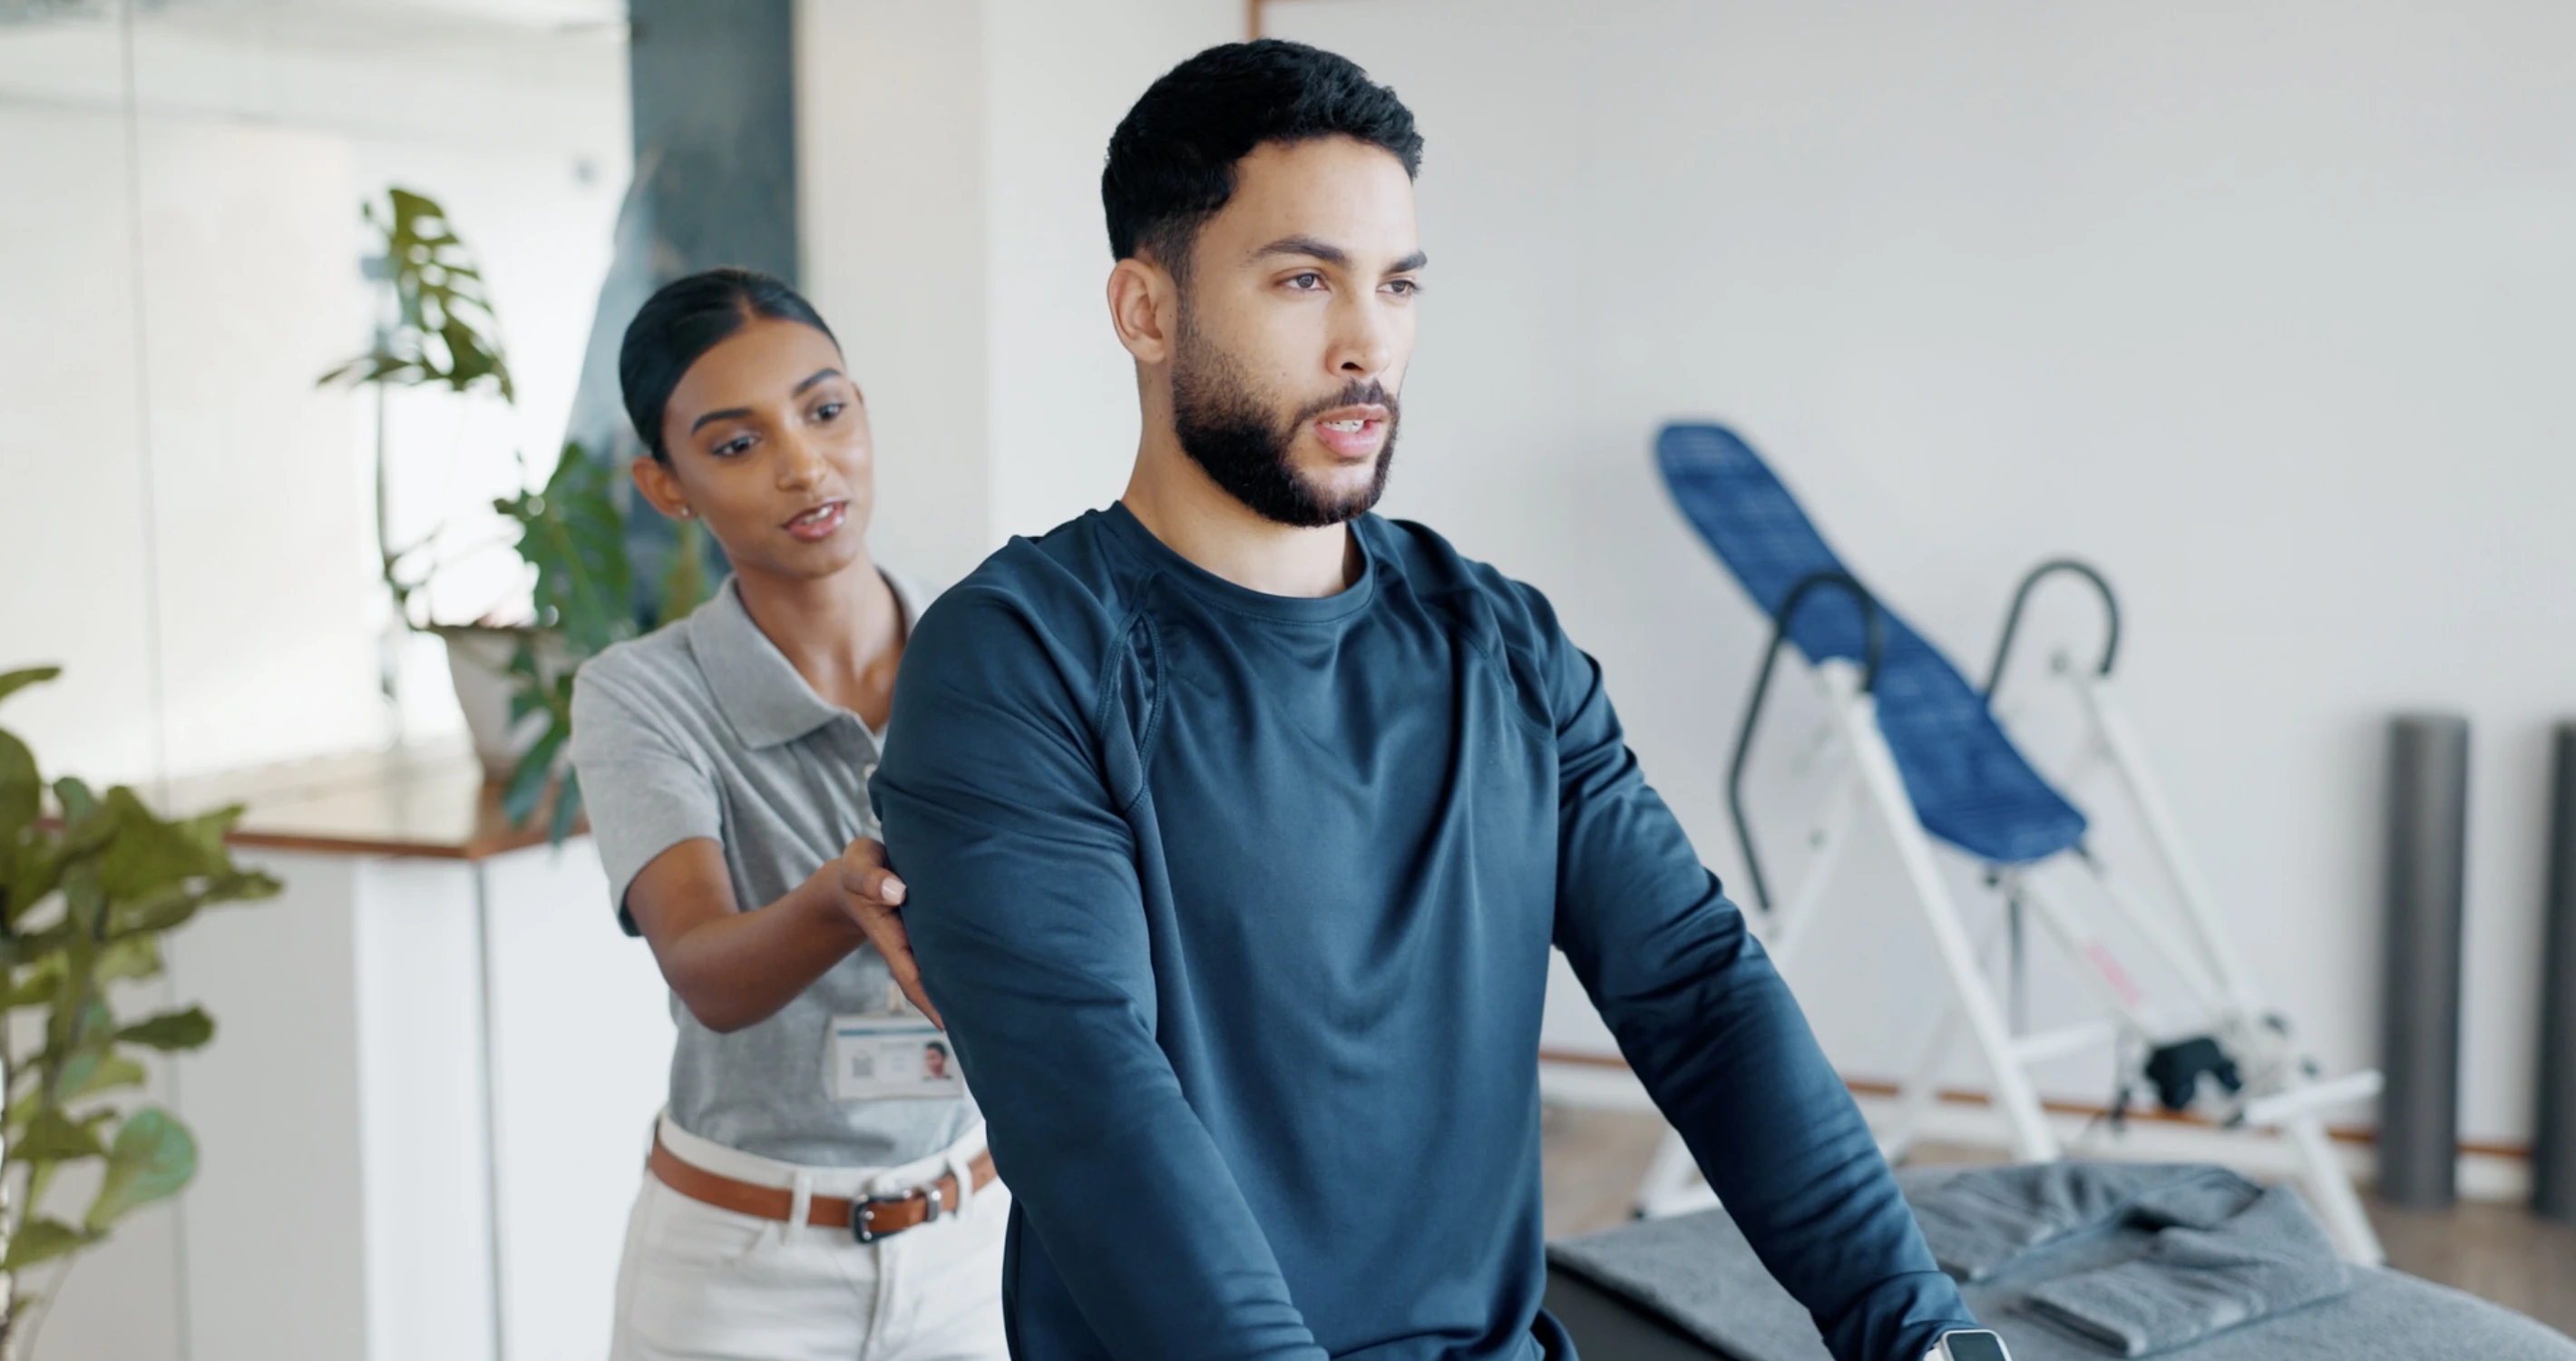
[0,0,629,781]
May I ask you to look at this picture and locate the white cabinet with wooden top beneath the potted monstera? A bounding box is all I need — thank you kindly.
[53,758,672,1361]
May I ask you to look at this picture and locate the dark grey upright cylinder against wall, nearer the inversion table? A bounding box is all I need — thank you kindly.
[2377,714,2468,1207]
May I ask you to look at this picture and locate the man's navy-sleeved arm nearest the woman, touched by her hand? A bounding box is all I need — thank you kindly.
[871,592,1324,1361]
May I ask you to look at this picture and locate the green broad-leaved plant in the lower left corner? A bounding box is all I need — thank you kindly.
[0,668,278,1358]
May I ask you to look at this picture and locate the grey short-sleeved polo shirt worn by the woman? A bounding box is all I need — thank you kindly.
[571,573,979,1168]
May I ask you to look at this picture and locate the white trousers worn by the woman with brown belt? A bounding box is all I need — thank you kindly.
[608,1116,1010,1361]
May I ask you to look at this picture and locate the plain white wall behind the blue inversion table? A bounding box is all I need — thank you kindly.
[1270,0,2576,1140]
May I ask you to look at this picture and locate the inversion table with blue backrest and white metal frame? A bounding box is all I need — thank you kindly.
[1638,426,2383,1263]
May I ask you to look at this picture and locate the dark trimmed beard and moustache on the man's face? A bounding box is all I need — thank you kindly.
[1172,304,1396,528]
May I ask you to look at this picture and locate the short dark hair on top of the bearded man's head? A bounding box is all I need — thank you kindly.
[1100,39,1422,276]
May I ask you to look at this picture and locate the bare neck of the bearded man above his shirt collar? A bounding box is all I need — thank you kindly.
[1118,426,1361,598]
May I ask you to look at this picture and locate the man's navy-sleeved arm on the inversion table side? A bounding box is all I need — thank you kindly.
[1530,592,1976,1361]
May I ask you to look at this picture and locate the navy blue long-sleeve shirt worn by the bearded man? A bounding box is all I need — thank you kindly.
[873,508,1973,1361]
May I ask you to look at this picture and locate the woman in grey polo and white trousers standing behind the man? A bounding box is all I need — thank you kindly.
[571,270,1007,1361]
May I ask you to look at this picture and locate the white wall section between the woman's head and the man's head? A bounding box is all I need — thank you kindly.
[796,0,1244,583]
